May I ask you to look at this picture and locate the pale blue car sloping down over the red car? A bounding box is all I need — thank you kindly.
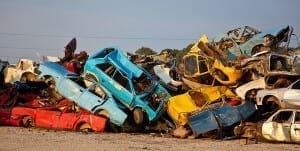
[39,62,127,126]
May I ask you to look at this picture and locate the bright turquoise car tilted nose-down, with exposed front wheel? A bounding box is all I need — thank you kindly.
[84,47,170,125]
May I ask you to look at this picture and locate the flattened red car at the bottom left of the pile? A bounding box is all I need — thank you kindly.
[0,86,107,132]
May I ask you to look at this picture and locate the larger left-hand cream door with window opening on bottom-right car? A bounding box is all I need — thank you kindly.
[262,111,294,142]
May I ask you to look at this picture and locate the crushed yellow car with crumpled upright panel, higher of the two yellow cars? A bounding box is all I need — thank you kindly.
[183,35,242,86]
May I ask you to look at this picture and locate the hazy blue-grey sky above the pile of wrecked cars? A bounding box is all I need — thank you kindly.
[0,0,300,62]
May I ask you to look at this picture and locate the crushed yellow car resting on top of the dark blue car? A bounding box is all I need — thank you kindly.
[167,86,237,126]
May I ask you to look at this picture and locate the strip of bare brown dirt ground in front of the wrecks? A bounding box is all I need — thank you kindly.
[0,126,300,151]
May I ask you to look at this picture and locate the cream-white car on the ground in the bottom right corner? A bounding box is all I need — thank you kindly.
[262,109,300,143]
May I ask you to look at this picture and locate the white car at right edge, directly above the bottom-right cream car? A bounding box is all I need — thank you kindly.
[256,79,300,109]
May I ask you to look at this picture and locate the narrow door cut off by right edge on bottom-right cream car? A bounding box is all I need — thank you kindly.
[291,111,300,143]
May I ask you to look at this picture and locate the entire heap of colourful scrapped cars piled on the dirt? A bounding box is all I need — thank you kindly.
[0,26,300,142]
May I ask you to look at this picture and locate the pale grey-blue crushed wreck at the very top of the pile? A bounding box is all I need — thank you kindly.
[213,25,293,60]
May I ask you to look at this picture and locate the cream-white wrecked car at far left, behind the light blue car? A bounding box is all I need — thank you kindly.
[4,59,37,83]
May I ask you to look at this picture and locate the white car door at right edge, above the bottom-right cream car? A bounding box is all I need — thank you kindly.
[283,80,300,107]
